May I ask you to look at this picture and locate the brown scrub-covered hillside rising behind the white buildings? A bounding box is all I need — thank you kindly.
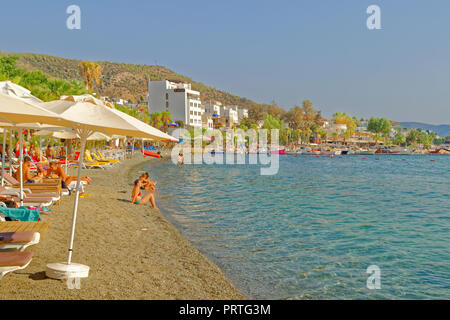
[0,52,268,108]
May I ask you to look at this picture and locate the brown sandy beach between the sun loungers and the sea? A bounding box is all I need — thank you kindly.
[0,155,244,300]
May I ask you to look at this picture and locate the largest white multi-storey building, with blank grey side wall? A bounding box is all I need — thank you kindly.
[148,80,204,127]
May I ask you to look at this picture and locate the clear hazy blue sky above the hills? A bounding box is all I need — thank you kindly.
[0,0,450,124]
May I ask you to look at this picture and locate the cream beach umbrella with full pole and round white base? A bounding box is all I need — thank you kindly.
[41,95,177,279]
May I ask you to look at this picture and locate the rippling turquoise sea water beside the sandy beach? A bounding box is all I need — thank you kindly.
[143,155,450,299]
